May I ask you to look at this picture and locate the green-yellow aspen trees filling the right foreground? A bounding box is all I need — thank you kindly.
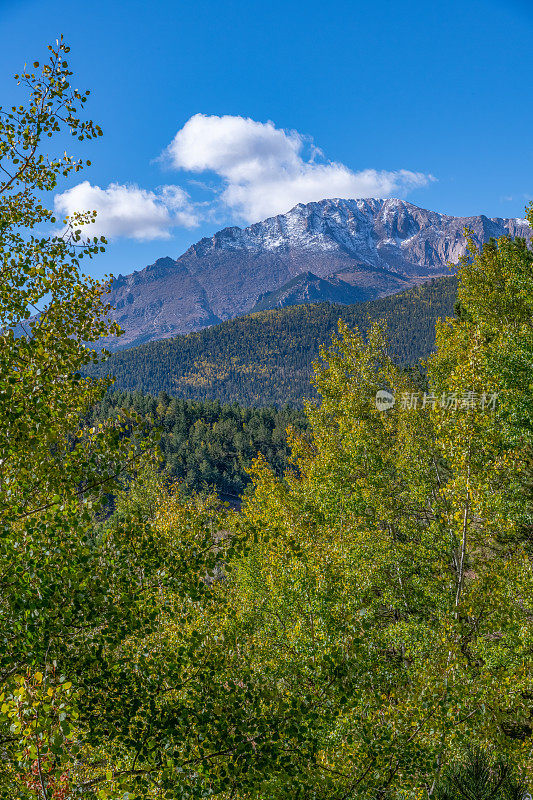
[216,217,533,798]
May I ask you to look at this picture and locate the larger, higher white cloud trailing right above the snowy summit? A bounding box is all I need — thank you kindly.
[163,114,434,222]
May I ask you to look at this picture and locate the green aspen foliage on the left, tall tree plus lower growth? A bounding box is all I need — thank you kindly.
[0,41,316,800]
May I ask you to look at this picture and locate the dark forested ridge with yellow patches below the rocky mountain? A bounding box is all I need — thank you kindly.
[93,276,457,405]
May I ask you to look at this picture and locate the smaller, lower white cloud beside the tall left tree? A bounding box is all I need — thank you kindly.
[54,181,198,240]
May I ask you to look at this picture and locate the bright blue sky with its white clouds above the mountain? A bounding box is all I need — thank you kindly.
[0,0,533,276]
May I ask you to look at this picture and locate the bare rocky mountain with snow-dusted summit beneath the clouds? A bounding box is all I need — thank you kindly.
[102,199,531,348]
